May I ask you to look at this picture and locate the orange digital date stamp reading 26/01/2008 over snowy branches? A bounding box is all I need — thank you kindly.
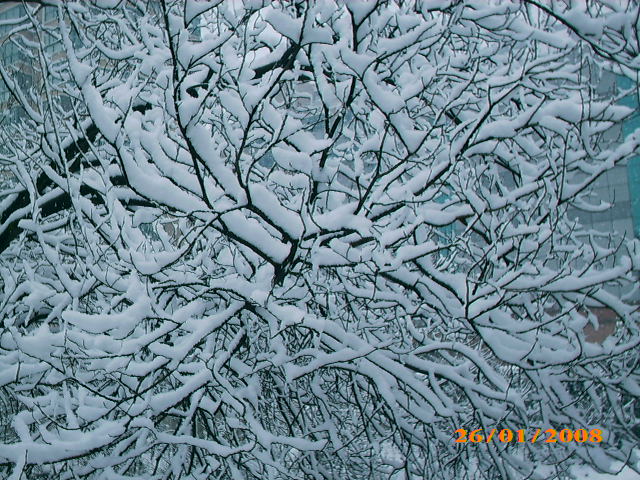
[454,428,602,443]
